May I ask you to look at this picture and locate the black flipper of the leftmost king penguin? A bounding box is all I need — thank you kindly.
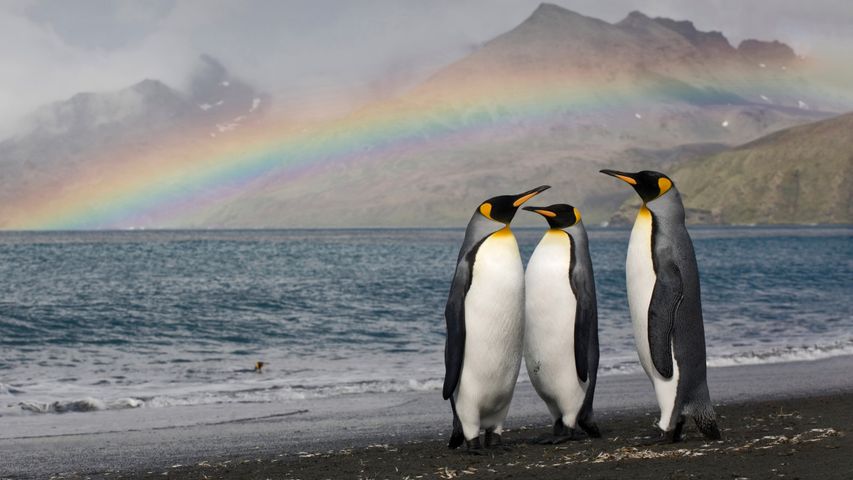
[441,255,473,400]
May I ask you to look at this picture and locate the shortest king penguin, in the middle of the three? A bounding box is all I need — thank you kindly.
[524,204,601,443]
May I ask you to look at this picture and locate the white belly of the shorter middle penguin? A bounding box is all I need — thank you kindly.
[524,231,589,428]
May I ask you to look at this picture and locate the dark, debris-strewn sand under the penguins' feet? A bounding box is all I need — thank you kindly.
[151,394,853,479]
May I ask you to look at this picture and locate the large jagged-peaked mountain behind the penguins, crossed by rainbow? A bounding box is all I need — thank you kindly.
[205,4,845,227]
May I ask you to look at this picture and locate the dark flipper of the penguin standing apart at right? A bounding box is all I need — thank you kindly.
[648,262,684,378]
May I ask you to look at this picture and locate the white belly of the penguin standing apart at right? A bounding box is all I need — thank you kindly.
[625,206,678,430]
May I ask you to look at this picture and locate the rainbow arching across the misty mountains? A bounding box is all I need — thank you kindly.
[0,65,828,230]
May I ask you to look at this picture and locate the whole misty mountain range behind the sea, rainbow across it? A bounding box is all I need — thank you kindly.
[0,4,853,228]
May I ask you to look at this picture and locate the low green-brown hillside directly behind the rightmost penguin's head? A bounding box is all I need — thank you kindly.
[611,113,853,225]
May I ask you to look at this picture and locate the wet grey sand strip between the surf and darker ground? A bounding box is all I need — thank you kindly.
[0,356,853,479]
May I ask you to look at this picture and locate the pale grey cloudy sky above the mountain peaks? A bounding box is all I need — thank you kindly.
[0,0,853,136]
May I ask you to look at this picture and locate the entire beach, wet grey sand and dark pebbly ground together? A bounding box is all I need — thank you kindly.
[0,356,853,479]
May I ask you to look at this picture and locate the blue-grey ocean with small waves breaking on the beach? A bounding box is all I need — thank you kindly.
[0,227,853,416]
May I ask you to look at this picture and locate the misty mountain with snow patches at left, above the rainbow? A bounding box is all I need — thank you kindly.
[0,56,266,227]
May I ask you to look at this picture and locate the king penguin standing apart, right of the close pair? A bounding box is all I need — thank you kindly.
[601,170,720,442]
